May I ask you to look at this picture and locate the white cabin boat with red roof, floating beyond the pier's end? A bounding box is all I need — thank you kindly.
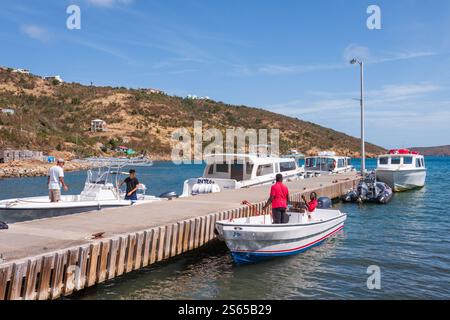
[376,149,427,192]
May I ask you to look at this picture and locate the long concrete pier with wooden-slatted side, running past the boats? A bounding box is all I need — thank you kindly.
[0,172,360,300]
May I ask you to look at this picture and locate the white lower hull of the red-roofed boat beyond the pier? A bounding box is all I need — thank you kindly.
[376,169,427,192]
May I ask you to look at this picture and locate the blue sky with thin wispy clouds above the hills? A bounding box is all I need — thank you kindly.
[0,0,450,147]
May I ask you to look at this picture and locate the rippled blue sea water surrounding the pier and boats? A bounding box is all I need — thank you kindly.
[0,158,450,299]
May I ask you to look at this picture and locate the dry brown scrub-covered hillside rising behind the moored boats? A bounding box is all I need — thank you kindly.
[0,68,383,159]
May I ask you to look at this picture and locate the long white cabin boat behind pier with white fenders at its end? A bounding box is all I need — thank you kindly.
[182,154,305,197]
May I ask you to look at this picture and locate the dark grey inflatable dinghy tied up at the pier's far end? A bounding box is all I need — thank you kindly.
[342,172,393,204]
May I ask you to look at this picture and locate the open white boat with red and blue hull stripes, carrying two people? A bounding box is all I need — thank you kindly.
[216,209,347,264]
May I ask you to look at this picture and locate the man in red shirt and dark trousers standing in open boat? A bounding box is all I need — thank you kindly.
[264,174,289,224]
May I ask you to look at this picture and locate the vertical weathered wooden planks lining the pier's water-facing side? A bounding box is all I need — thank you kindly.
[0,179,359,300]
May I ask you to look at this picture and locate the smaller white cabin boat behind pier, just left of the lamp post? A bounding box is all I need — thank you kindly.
[305,151,355,177]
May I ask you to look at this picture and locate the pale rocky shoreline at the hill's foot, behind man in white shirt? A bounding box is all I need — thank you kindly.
[0,161,97,179]
